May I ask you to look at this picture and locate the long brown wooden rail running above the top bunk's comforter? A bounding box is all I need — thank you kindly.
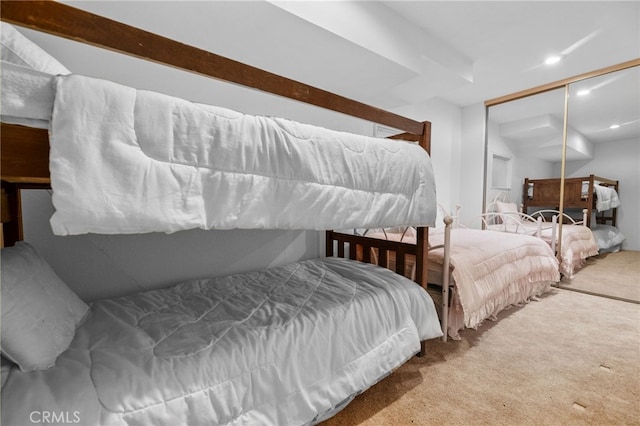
[1,0,429,146]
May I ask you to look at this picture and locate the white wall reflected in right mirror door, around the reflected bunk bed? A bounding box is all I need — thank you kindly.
[558,139,640,250]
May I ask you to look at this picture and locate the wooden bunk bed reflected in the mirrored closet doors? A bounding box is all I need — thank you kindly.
[522,175,620,228]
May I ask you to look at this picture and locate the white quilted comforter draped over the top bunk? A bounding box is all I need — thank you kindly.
[50,75,436,235]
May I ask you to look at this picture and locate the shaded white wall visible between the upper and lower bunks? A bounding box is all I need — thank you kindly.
[23,190,321,300]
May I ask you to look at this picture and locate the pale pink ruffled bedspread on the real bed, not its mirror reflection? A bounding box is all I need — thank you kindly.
[367,228,560,339]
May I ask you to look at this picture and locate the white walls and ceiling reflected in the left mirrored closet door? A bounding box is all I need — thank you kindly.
[485,88,565,218]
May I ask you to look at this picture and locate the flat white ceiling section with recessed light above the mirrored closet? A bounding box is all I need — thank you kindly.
[384,1,640,106]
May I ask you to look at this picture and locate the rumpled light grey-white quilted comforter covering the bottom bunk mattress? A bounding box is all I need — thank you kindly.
[2,258,442,426]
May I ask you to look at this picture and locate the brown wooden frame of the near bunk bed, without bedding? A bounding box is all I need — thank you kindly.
[0,1,431,288]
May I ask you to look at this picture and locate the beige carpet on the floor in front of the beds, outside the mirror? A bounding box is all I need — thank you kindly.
[323,289,640,426]
